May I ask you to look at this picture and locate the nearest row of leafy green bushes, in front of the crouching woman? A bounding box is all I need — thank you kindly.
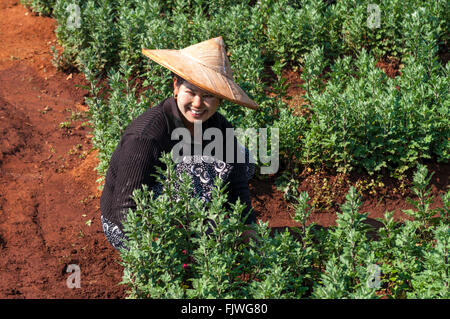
[121,154,450,299]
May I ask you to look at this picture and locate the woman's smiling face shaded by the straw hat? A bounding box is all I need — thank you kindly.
[173,77,221,129]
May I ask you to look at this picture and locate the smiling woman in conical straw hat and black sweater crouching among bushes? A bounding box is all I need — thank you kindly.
[100,37,258,249]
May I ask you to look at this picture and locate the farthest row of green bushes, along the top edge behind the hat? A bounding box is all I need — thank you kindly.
[26,0,449,69]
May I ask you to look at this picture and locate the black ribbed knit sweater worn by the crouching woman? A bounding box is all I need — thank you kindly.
[100,97,256,231]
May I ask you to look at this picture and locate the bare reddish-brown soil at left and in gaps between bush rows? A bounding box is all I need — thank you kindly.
[0,0,450,298]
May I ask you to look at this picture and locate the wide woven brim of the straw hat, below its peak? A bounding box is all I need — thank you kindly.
[142,49,258,110]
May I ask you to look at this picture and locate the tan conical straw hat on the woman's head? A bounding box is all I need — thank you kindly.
[142,37,258,109]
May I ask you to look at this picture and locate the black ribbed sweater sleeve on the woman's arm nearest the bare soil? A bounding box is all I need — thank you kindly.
[111,135,160,228]
